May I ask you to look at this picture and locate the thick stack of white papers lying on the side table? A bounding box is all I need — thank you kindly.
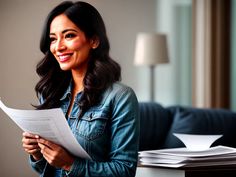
[139,146,236,168]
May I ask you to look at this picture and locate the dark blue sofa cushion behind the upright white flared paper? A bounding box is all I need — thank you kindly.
[163,107,236,148]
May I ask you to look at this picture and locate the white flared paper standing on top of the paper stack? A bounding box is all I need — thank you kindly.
[173,133,222,150]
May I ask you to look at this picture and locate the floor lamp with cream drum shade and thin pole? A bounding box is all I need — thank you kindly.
[134,33,169,101]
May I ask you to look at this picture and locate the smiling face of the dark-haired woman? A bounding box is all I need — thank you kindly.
[50,14,96,72]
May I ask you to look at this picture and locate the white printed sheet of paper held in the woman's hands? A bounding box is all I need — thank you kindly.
[0,100,90,159]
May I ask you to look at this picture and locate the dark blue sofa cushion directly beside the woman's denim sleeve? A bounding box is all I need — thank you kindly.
[139,102,172,151]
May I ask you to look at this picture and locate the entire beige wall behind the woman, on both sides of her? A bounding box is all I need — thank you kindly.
[0,0,156,177]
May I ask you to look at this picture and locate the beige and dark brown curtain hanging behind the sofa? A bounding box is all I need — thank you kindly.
[192,0,231,108]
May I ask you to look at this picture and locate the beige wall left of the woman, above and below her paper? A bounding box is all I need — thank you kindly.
[0,1,48,177]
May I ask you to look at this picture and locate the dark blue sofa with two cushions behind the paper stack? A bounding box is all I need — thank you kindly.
[139,102,236,151]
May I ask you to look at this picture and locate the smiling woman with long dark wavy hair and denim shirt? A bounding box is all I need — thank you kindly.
[22,1,139,177]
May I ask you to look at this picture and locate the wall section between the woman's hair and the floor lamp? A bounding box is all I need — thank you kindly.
[90,0,156,101]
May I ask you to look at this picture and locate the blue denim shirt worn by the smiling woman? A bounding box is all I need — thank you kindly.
[30,82,139,177]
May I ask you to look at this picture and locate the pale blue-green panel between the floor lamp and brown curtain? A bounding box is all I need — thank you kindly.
[156,0,192,106]
